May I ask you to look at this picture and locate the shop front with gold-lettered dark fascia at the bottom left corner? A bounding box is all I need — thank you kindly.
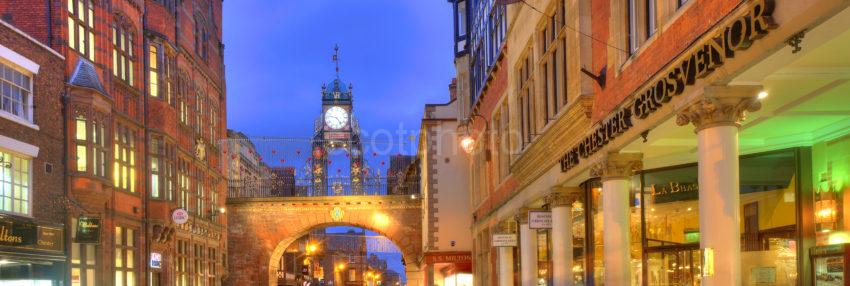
[0,216,67,286]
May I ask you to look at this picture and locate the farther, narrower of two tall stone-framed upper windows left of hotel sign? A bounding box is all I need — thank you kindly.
[517,50,536,146]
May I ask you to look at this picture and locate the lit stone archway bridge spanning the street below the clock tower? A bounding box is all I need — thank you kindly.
[225,196,422,286]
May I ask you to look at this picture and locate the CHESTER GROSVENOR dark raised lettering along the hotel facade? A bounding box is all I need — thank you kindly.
[559,0,776,172]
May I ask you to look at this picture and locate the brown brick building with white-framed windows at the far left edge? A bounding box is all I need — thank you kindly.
[0,17,67,284]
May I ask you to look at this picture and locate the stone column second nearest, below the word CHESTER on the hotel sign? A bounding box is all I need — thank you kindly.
[591,153,643,285]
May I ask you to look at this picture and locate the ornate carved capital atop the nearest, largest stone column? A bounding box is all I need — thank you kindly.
[676,85,762,132]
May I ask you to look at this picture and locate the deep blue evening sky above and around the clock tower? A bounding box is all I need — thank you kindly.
[223,0,454,141]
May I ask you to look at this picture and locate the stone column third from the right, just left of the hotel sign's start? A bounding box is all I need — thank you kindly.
[546,187,580,286]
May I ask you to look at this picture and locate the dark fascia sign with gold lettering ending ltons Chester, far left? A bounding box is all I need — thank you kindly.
[0,216,64,252]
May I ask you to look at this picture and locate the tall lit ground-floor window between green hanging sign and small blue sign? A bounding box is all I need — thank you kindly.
[115,226,138,286]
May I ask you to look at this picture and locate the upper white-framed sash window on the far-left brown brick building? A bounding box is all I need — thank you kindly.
[0,63,32,122]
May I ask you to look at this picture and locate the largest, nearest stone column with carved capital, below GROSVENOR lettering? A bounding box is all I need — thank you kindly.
[676,86,761,286]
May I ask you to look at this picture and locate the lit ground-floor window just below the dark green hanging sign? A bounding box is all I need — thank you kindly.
[69,218,98,286]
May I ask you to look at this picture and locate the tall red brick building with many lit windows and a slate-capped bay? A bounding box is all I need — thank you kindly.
[0,0,226,285]
